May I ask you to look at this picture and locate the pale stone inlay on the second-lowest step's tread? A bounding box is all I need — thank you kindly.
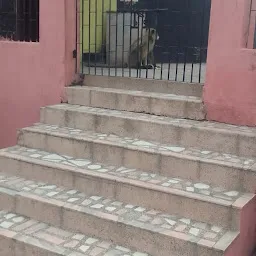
[0,173,228,245]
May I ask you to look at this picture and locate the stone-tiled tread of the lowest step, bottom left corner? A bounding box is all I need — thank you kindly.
[0,211,149,256]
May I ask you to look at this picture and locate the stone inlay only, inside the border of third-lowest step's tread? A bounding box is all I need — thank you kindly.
[2,146,248,203]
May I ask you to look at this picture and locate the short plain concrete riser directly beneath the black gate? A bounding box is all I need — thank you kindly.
[81,75,203,97]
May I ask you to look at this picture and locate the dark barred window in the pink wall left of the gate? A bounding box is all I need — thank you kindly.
[0,0,39,42]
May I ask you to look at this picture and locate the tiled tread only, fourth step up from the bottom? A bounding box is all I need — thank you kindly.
[22,123,256,172]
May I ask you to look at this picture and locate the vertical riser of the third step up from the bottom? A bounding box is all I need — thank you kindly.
[0,157,240,229]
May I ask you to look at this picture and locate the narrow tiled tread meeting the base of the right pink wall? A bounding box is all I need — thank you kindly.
[46,103,256,137]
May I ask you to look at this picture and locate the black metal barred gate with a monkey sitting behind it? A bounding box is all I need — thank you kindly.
[78,0,211,82]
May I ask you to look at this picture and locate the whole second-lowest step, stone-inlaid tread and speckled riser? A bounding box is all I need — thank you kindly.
[0,173,246,256]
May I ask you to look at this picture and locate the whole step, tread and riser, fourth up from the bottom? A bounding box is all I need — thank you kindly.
[18,124,256,193]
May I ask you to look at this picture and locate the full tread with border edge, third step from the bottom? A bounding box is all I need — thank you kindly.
[0,146,254,209]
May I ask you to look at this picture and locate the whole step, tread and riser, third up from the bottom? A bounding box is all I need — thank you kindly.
[0,147,256,229]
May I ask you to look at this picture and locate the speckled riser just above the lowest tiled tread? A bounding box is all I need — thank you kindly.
[0,193,224,256]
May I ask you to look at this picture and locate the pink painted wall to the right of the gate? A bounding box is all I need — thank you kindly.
[204,0,256,126]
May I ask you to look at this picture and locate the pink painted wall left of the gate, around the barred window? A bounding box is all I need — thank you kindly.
[0,0,75,148]
